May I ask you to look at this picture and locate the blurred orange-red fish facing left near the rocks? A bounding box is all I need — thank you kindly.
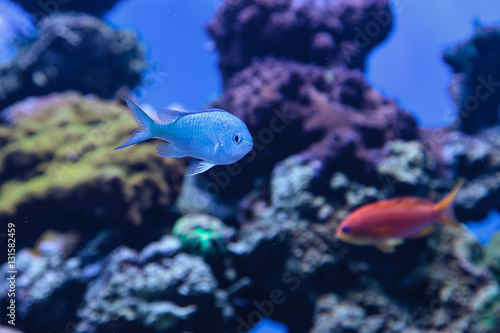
[335,181,462,253]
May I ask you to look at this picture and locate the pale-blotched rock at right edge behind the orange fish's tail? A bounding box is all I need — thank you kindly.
[421,126,500,221]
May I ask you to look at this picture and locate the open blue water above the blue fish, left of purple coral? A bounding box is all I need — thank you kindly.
[106,0,222,109]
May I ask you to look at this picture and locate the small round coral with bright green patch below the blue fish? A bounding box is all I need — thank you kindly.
[172,214,234,256]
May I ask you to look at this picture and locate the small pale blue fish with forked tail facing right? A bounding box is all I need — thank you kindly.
[115,98,253,176]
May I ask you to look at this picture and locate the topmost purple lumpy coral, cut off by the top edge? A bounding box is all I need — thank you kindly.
[207,0,392,81]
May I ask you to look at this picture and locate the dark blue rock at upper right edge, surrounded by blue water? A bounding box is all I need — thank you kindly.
[444,23,500,133]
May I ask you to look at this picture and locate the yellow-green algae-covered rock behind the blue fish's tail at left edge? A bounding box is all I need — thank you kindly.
[0,93,184,241]
